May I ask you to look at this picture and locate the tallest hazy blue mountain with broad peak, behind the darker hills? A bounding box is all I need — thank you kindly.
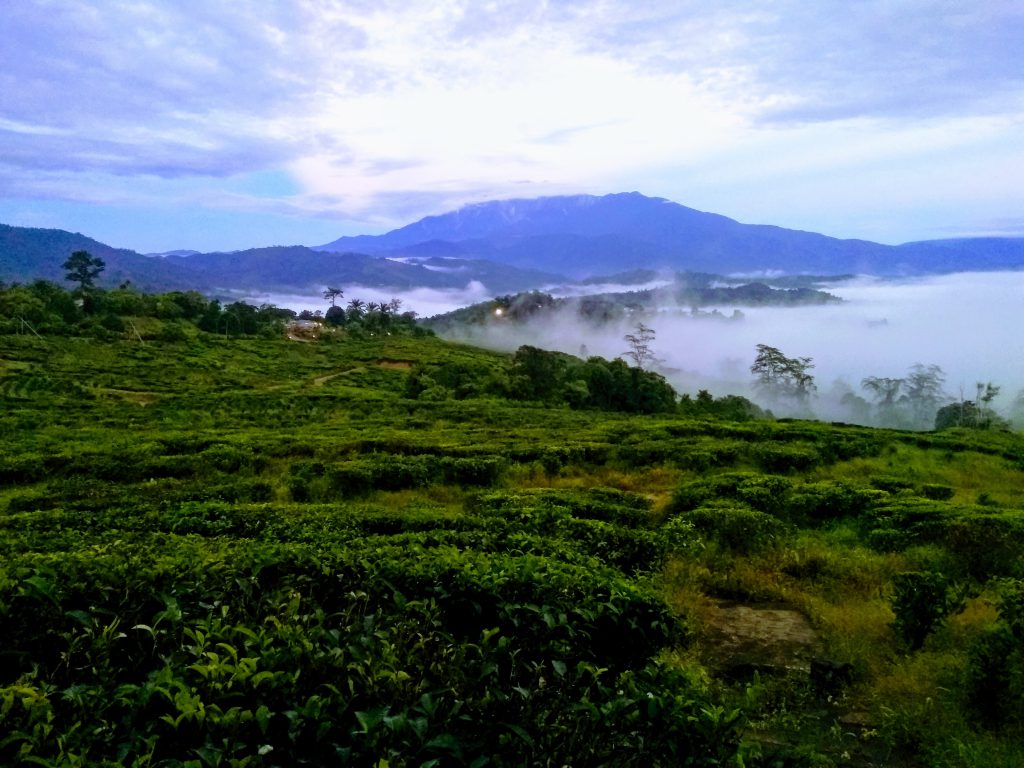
[316,193,1024,278]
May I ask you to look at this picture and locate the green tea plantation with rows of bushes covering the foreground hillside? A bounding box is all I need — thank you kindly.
[0,331,1024,768]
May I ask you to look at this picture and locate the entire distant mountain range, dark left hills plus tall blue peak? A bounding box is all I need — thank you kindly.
[0,193,1024,294]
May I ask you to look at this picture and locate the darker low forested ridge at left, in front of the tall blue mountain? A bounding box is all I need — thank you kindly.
[0,224,565,293]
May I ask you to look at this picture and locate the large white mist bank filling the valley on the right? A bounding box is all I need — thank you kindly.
[438,272,1024,418]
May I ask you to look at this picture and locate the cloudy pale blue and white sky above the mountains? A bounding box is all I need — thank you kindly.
[0,0,1024,252]
